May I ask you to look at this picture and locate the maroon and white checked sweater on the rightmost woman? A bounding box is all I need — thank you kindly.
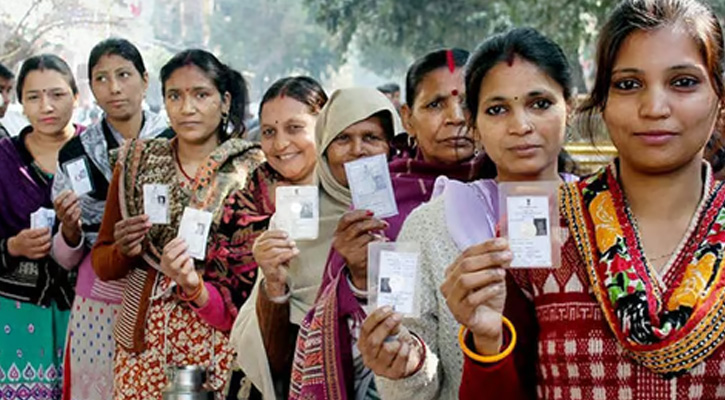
[460,239,725,400]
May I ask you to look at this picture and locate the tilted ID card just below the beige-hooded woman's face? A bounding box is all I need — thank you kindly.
[345,154,398,218]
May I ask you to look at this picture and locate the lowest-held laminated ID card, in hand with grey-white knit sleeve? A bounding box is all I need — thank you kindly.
[368,242,420,318]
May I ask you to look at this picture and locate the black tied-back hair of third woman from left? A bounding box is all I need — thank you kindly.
[161,49,249,141]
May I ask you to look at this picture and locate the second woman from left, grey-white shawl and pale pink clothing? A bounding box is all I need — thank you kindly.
[51,38,167,400]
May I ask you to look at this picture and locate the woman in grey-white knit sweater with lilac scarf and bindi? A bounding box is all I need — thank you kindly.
[360,29,573,399]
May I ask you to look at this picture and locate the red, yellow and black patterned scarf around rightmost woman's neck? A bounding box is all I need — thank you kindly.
[561,163,725,377]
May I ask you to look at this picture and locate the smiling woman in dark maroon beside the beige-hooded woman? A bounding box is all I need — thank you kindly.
[209,76,327,399]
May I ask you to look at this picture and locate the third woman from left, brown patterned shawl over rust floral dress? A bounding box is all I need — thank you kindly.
[91,50,263,399]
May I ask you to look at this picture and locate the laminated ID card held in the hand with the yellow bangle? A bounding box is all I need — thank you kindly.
[498,181,561,268]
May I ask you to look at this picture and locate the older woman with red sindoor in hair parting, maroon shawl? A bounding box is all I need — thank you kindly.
[292,49,495,399]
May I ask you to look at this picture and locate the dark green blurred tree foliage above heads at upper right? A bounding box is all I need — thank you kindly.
[304,0,725,81]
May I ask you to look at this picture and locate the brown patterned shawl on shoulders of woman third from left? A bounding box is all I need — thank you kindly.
[114,139,264,351]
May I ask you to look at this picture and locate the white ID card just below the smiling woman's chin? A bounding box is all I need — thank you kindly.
[274,185,320,240]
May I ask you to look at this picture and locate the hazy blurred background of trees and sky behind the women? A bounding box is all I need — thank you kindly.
[5,0,725,169]
